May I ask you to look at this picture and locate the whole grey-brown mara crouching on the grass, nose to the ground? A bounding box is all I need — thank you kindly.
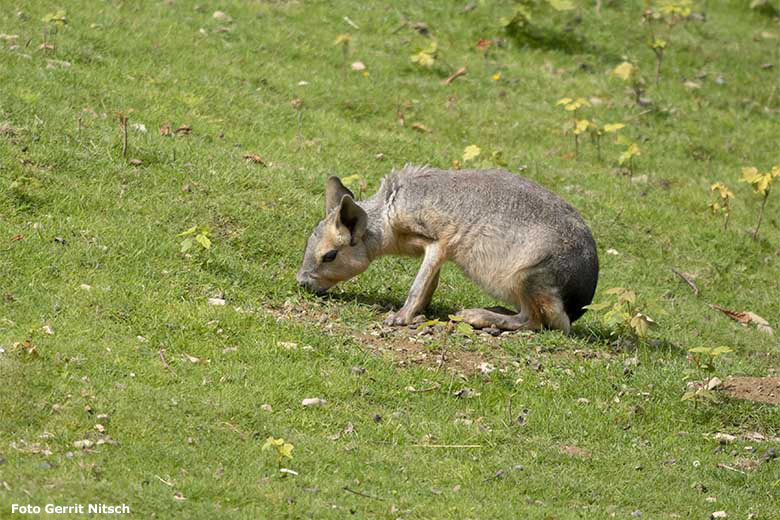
[297,165,598,332]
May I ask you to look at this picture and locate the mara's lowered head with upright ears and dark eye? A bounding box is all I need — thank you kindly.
[296,177,370,294]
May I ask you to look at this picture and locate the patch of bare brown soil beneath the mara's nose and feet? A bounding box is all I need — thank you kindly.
[264,301,609,376]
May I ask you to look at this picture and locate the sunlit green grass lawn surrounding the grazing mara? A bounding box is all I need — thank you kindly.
[0,0,780,519]
